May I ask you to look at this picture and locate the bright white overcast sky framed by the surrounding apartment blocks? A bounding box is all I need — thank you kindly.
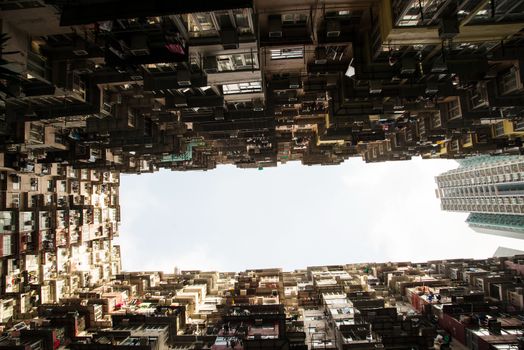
[118,158,524,272]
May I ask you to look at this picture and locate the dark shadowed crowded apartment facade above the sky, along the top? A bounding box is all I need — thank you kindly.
[0,0,524,173]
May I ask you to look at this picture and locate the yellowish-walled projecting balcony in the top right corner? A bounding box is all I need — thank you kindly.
[378,0,522,46]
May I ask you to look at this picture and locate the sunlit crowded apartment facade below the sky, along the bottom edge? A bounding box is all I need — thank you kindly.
[0,256,524,350]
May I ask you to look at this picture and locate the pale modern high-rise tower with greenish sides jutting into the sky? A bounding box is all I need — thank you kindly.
[436,156,524,238]
